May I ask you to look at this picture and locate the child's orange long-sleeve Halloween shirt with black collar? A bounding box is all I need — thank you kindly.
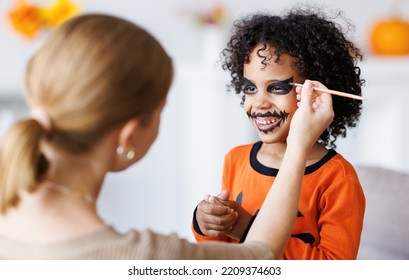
[192,142,365,260]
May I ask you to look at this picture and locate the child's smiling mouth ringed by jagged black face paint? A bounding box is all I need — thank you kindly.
[247,111,290,133]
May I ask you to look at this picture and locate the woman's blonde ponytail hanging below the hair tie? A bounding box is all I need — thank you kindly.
[0,119,48,214]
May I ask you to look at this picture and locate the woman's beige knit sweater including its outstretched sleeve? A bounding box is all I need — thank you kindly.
[0,226,273,260]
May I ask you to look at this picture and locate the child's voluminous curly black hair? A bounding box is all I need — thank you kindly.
[221,5,365,148]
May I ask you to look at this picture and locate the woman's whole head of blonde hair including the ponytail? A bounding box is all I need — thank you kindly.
[0,14,173,213]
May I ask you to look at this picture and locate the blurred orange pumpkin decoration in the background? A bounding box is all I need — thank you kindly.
[370,18,409,55]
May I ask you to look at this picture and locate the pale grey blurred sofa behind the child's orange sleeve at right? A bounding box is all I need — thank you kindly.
[356,166,409,260]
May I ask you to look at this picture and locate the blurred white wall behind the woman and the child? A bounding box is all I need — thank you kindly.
[0,0,409,239]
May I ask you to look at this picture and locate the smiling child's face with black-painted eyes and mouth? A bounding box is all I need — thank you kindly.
[243,46,302,144]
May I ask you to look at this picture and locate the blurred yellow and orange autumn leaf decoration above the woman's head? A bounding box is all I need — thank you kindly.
[8,0,80,39]
